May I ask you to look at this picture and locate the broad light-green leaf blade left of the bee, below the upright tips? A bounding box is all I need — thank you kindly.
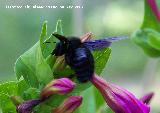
[15,42,53,87]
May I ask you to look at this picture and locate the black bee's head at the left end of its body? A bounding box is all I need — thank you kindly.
[52,33,68,56]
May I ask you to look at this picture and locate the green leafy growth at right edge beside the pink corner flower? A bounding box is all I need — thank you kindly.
[131,0,160,57]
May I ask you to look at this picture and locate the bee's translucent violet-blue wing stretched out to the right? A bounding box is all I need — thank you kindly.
[83,36,127,51]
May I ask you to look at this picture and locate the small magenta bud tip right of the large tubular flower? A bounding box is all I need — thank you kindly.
[140,92,154,104]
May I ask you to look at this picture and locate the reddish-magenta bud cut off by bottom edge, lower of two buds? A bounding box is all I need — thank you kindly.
[52,96,82,113]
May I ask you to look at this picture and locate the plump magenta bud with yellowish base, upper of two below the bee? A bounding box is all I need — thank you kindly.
[40,78,75,99]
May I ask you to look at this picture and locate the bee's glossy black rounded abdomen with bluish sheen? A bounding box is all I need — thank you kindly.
[66,47,94,83]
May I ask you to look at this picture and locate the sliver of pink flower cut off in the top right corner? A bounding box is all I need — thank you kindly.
[147,0,160,21]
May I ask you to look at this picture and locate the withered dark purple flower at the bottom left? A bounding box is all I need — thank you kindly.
[16,99,42,113]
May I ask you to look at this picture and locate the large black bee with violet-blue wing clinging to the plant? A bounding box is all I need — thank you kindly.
[52,33,124,83]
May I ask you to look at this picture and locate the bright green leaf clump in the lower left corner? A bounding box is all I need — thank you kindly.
[0,80,40,113]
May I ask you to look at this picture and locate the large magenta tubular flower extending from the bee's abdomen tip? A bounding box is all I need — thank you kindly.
[91,75,150,113]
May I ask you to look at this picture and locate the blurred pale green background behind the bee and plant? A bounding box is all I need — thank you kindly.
[0,0,160,113]
